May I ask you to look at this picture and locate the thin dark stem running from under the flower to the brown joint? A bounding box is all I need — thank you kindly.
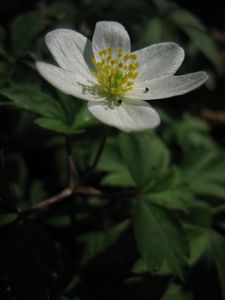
[81,126,110,183]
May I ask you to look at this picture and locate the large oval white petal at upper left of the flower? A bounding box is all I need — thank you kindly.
[45,29,93,77]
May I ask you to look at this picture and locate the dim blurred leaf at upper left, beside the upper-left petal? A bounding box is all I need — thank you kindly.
[11,11,45,56]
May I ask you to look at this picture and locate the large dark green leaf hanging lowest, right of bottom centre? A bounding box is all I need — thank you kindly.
[133,199,188,278]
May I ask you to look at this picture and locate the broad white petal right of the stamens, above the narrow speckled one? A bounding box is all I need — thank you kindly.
[134,43,184,81]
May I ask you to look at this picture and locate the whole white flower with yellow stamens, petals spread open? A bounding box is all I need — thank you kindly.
[36,22,208,132]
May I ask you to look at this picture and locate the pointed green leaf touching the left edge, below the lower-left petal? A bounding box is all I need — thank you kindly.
[0,86,65,119]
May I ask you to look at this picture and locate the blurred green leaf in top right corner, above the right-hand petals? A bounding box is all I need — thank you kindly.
[167,8,206,32]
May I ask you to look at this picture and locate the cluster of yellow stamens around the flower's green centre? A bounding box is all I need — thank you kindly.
[92,48,139,101]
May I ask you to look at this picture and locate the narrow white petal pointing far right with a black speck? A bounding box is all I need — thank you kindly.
[127,72,208,100]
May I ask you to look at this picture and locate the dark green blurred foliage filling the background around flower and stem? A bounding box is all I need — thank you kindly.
[0,0,225,300]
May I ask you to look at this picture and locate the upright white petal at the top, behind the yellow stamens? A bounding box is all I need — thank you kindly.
[92,21,130,60]
